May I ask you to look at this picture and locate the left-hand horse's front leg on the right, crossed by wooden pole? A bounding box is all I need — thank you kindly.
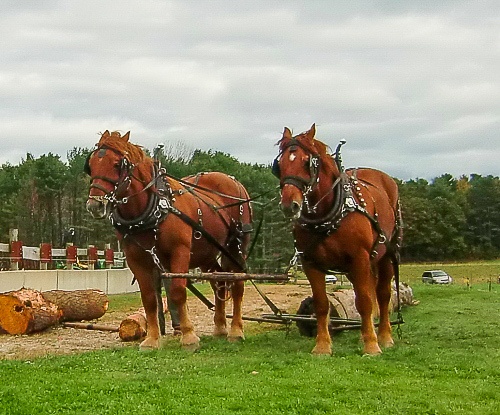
[170,252,200,348]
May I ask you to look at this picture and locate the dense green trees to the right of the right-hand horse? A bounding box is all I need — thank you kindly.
[399,174,500,261]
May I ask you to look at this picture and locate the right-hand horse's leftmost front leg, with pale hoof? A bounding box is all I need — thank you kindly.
[303,263,332,355]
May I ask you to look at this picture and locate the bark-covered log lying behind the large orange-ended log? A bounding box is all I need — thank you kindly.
[42,290,109,321]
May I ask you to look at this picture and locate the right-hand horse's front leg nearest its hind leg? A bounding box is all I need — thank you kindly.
[349,252,382,355]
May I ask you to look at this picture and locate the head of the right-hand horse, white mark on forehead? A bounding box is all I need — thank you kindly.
[273,124,326,219]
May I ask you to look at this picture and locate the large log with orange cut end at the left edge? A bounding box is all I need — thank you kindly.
[0,288,62,334]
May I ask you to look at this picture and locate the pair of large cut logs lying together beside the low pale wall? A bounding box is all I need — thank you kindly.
[0,288,108,334]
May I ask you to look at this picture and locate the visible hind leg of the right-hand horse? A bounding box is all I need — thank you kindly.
[377,256,394,347]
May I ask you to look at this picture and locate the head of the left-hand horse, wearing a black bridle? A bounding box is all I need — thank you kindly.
[84,130,135,219]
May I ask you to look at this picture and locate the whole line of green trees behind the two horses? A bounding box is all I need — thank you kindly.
[0,146,500,272]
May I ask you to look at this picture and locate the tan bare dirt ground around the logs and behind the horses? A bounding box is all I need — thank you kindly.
[0,284,311,360]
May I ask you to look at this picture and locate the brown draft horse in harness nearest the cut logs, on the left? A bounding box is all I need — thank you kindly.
[85,131,252,349]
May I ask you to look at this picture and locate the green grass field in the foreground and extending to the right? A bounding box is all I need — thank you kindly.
[0,263,500,415]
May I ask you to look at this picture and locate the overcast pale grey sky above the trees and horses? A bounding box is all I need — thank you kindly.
[0,0,500,180]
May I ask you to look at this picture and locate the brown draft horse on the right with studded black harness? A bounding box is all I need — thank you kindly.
[273,125,402,355]
